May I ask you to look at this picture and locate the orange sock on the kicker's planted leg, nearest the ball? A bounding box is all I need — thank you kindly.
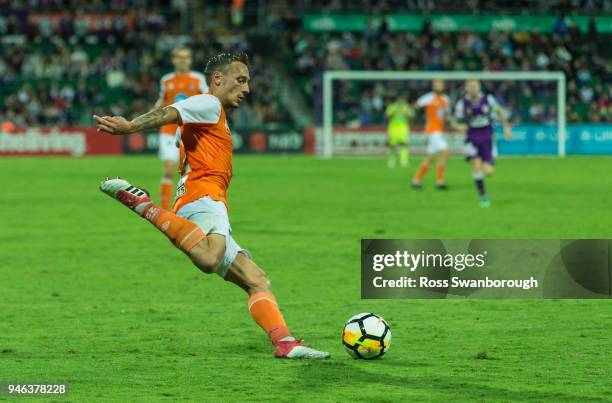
[249,292,291,344]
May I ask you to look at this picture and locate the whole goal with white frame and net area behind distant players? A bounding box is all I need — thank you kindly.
[322,71,567,158]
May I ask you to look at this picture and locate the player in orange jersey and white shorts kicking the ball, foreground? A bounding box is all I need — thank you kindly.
[94,52,329,359]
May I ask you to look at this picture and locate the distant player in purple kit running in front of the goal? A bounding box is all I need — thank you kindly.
[455,80,512,207]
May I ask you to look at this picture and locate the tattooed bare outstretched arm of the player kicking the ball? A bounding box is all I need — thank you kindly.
[93,107,181,135]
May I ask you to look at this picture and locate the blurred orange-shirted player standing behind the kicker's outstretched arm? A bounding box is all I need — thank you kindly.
[153,47,208,210]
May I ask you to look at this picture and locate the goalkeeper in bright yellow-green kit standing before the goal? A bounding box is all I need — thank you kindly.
[385,94,414,168]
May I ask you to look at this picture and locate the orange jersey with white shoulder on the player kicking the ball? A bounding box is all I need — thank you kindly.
[172,94,232,212]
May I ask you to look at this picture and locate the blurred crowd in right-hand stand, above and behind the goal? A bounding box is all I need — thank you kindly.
[289,14,612,126]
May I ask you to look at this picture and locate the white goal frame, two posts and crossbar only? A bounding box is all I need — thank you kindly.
[322,70,567,158]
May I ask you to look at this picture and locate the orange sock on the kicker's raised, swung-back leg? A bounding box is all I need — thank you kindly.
[140,203,206,253]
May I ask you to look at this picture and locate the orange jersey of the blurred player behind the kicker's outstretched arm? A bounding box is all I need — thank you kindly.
[159,71,208,136]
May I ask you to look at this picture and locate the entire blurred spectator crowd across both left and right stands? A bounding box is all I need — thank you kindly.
[0,0,612,127]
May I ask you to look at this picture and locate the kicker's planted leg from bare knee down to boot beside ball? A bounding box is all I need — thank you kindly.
[225,252,330,359]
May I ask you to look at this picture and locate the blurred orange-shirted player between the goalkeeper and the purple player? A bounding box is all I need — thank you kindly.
[412,80,450,190]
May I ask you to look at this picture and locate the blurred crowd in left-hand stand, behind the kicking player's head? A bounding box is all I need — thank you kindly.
[0,0,288,127]
